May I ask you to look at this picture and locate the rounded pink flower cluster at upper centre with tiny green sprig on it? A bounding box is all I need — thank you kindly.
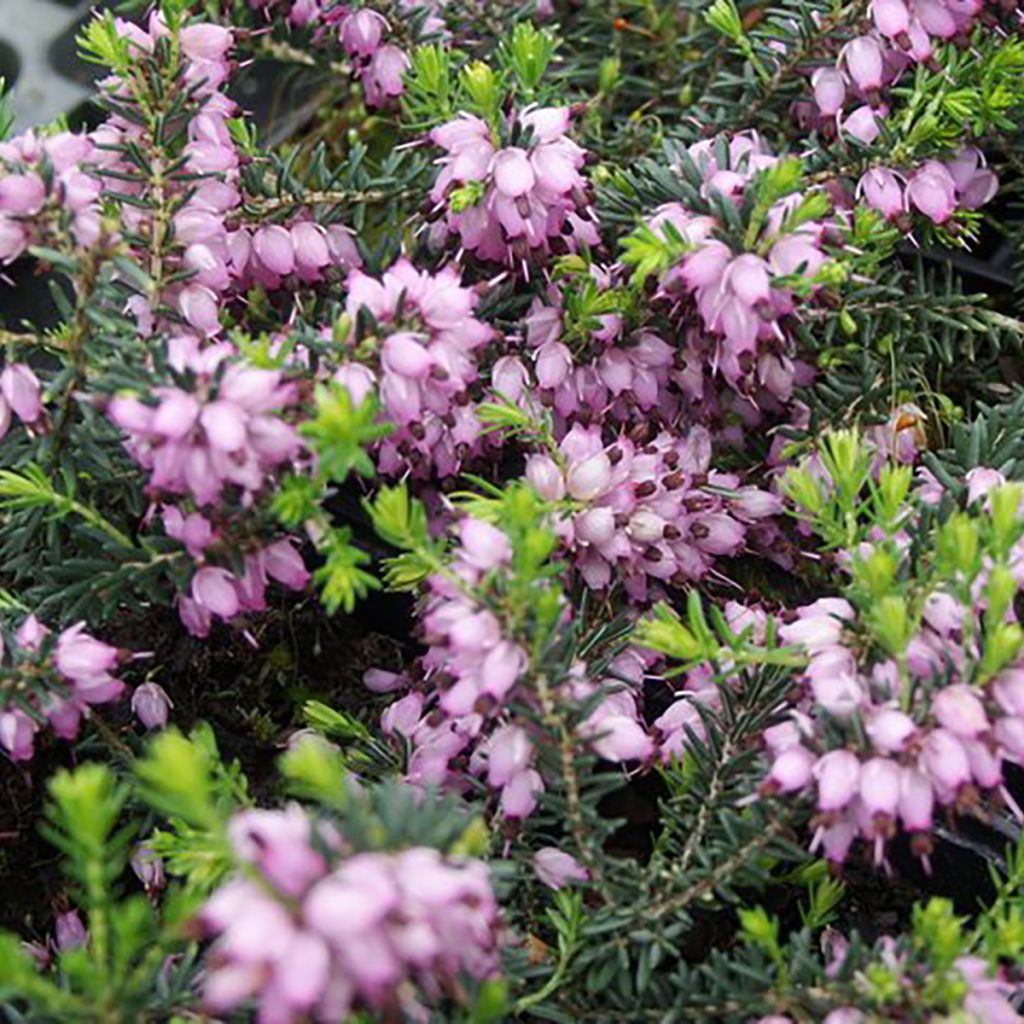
[430,106,600,275]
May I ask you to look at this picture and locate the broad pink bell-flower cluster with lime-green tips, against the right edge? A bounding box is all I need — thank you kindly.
[762,474,1024,861]
